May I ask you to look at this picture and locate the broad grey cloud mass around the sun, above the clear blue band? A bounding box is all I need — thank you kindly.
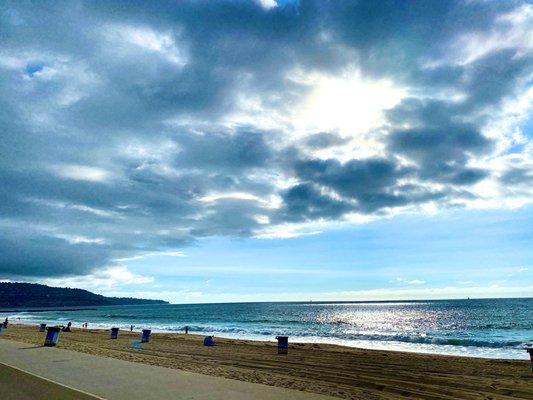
[0,0,532,278]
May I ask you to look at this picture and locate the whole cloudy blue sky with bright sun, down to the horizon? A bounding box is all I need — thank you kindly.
[0,0,533,303]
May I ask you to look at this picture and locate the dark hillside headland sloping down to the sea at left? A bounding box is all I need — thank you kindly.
[0,282,168,309]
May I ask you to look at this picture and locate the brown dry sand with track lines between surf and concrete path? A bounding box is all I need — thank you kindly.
[2,325,533,399]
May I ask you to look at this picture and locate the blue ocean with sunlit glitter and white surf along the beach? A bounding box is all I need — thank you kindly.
[2,298,533,359]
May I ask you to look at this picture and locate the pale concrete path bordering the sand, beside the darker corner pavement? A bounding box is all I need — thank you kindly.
[0,339,333,400]
